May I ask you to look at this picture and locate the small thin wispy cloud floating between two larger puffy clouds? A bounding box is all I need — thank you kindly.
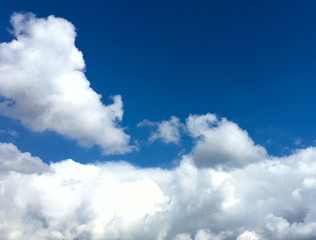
[137,116,182,144]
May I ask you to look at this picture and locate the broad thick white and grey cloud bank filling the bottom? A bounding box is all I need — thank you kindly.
[0,144,316,240]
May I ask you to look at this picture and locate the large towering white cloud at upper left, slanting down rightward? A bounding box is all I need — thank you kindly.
[0,14,132,154]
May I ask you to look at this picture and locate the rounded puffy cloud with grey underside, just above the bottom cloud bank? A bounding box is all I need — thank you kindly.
[186,114,267,167]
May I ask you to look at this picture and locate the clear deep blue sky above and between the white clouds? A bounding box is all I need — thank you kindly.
[0,0,316,166]
